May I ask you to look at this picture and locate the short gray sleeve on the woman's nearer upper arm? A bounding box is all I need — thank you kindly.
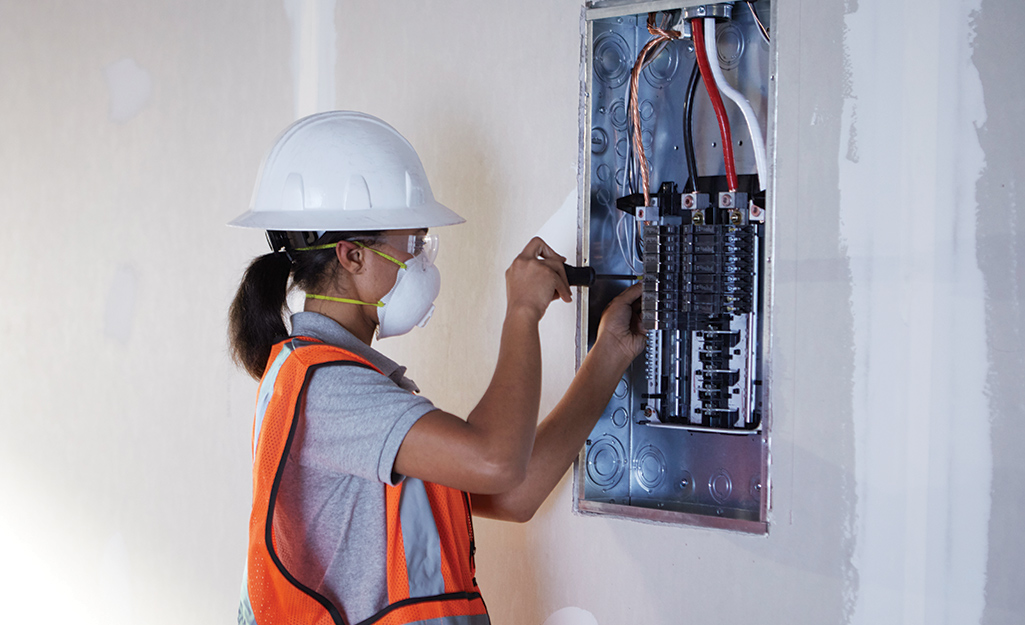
[296,365,435,485]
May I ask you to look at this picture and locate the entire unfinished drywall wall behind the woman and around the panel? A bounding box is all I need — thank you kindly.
[0,0,1025,625]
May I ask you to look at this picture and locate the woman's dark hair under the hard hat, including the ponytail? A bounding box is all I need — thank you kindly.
[228,232,380,380]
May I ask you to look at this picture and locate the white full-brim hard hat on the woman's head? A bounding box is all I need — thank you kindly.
[229,111,465,232]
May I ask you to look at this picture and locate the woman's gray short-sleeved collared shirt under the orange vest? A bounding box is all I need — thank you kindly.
[274,313,435,623]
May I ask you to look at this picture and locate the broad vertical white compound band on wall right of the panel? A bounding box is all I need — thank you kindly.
[838,0,992,624]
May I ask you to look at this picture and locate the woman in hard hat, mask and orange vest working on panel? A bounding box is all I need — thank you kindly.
[230,112,644,625]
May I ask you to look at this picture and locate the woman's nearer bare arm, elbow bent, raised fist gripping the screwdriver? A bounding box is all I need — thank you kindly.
[395,238,571,493]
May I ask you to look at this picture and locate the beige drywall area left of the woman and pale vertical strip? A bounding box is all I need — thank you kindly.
[0,0,293,624]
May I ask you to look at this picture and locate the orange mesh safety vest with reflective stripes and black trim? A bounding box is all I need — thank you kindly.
[239,338,491,625]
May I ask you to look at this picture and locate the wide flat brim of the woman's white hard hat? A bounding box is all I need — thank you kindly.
[228,202,466,232]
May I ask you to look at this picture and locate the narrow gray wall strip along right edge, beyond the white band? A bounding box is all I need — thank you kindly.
[973,0,1025,625]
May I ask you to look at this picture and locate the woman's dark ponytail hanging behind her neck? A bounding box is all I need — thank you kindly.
[228,252,292,380]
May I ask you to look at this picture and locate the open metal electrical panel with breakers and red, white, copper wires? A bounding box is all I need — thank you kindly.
[574,0,772,533]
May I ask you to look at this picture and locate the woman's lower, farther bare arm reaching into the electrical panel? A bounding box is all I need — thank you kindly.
[474,285,644,523]
